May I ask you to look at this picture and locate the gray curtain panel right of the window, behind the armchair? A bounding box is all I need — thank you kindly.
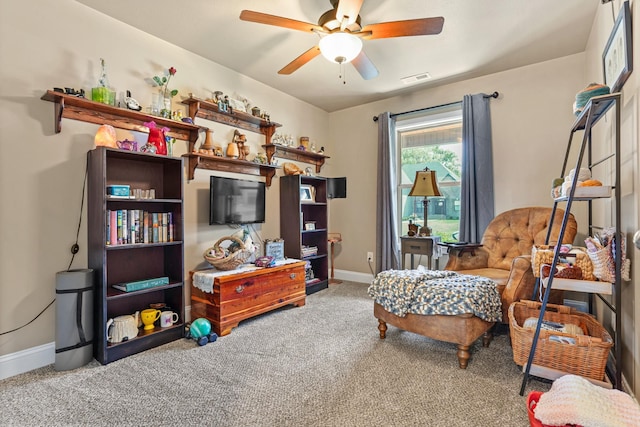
[458,94,494,243]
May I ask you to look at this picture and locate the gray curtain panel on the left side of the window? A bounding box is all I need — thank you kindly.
[376,112,400,273]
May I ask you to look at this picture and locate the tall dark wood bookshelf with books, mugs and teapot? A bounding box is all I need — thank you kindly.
[87,147,185,364]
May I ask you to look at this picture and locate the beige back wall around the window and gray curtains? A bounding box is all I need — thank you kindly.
[330,54,585,273]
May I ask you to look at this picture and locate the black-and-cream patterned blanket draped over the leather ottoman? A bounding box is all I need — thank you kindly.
[368,266,502,322]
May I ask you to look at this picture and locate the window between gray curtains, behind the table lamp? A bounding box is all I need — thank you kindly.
[396,103,462,241]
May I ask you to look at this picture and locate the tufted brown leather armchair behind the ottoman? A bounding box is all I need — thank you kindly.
[445,207,578,323]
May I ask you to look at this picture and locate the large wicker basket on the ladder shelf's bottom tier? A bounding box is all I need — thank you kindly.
[509,301,613,381]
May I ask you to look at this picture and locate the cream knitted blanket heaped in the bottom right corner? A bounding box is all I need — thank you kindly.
[534,375,640,427]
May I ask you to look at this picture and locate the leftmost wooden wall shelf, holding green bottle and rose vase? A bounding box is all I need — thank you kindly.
[40,90,200,145]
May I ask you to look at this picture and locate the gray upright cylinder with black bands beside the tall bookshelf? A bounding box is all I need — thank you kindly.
[54,269,94,371]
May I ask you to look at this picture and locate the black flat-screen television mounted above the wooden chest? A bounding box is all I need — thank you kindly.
[209,176,265,225]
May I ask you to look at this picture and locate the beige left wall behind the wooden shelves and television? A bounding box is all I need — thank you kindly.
[0,0,333,362]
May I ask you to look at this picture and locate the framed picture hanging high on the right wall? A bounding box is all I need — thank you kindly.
[602,1,633,93]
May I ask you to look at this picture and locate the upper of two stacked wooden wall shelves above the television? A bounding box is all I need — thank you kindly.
[182,96,282,152]
